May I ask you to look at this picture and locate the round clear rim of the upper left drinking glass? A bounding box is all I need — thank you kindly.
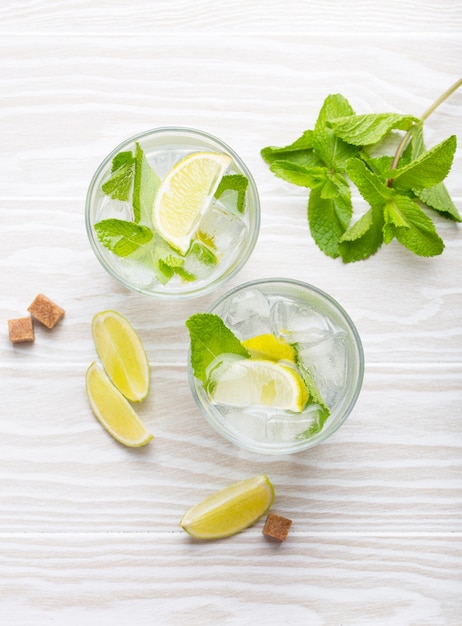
[85,126,261,300]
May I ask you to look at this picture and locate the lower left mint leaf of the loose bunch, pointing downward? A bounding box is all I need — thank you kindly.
[308,182,353,258]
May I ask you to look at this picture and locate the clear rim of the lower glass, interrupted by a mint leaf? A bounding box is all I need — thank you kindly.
[188,277,364,456]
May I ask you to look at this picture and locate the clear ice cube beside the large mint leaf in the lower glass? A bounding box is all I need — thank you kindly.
[222,287,270,339]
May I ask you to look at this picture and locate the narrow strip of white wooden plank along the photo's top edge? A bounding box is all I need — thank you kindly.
[0,0,462,34]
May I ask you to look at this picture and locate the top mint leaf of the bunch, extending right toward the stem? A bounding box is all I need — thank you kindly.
[329,113,420,146]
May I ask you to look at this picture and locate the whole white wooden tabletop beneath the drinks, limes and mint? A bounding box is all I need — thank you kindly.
[0,0,462,626]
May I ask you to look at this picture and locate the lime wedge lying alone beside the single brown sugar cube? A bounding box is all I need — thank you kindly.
[180,474,274,539]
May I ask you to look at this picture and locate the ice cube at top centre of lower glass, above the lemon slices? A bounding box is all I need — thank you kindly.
[270,300,332,345]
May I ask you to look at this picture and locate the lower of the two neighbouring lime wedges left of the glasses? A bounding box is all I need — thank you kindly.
[86,363,153,448]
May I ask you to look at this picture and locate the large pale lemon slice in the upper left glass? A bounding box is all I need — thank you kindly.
[152,152,231,254]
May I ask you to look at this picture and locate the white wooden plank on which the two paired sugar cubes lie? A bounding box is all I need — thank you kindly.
[0,196,462,364]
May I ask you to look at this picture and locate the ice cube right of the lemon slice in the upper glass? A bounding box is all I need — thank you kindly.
[199,204,247,264]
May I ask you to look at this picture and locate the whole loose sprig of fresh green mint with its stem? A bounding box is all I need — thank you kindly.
[261,81,462,263]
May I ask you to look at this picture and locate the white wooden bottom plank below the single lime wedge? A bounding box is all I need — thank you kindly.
[0,522,462,626]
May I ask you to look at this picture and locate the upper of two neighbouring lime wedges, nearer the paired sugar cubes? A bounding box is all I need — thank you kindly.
[92,311,149,402]
